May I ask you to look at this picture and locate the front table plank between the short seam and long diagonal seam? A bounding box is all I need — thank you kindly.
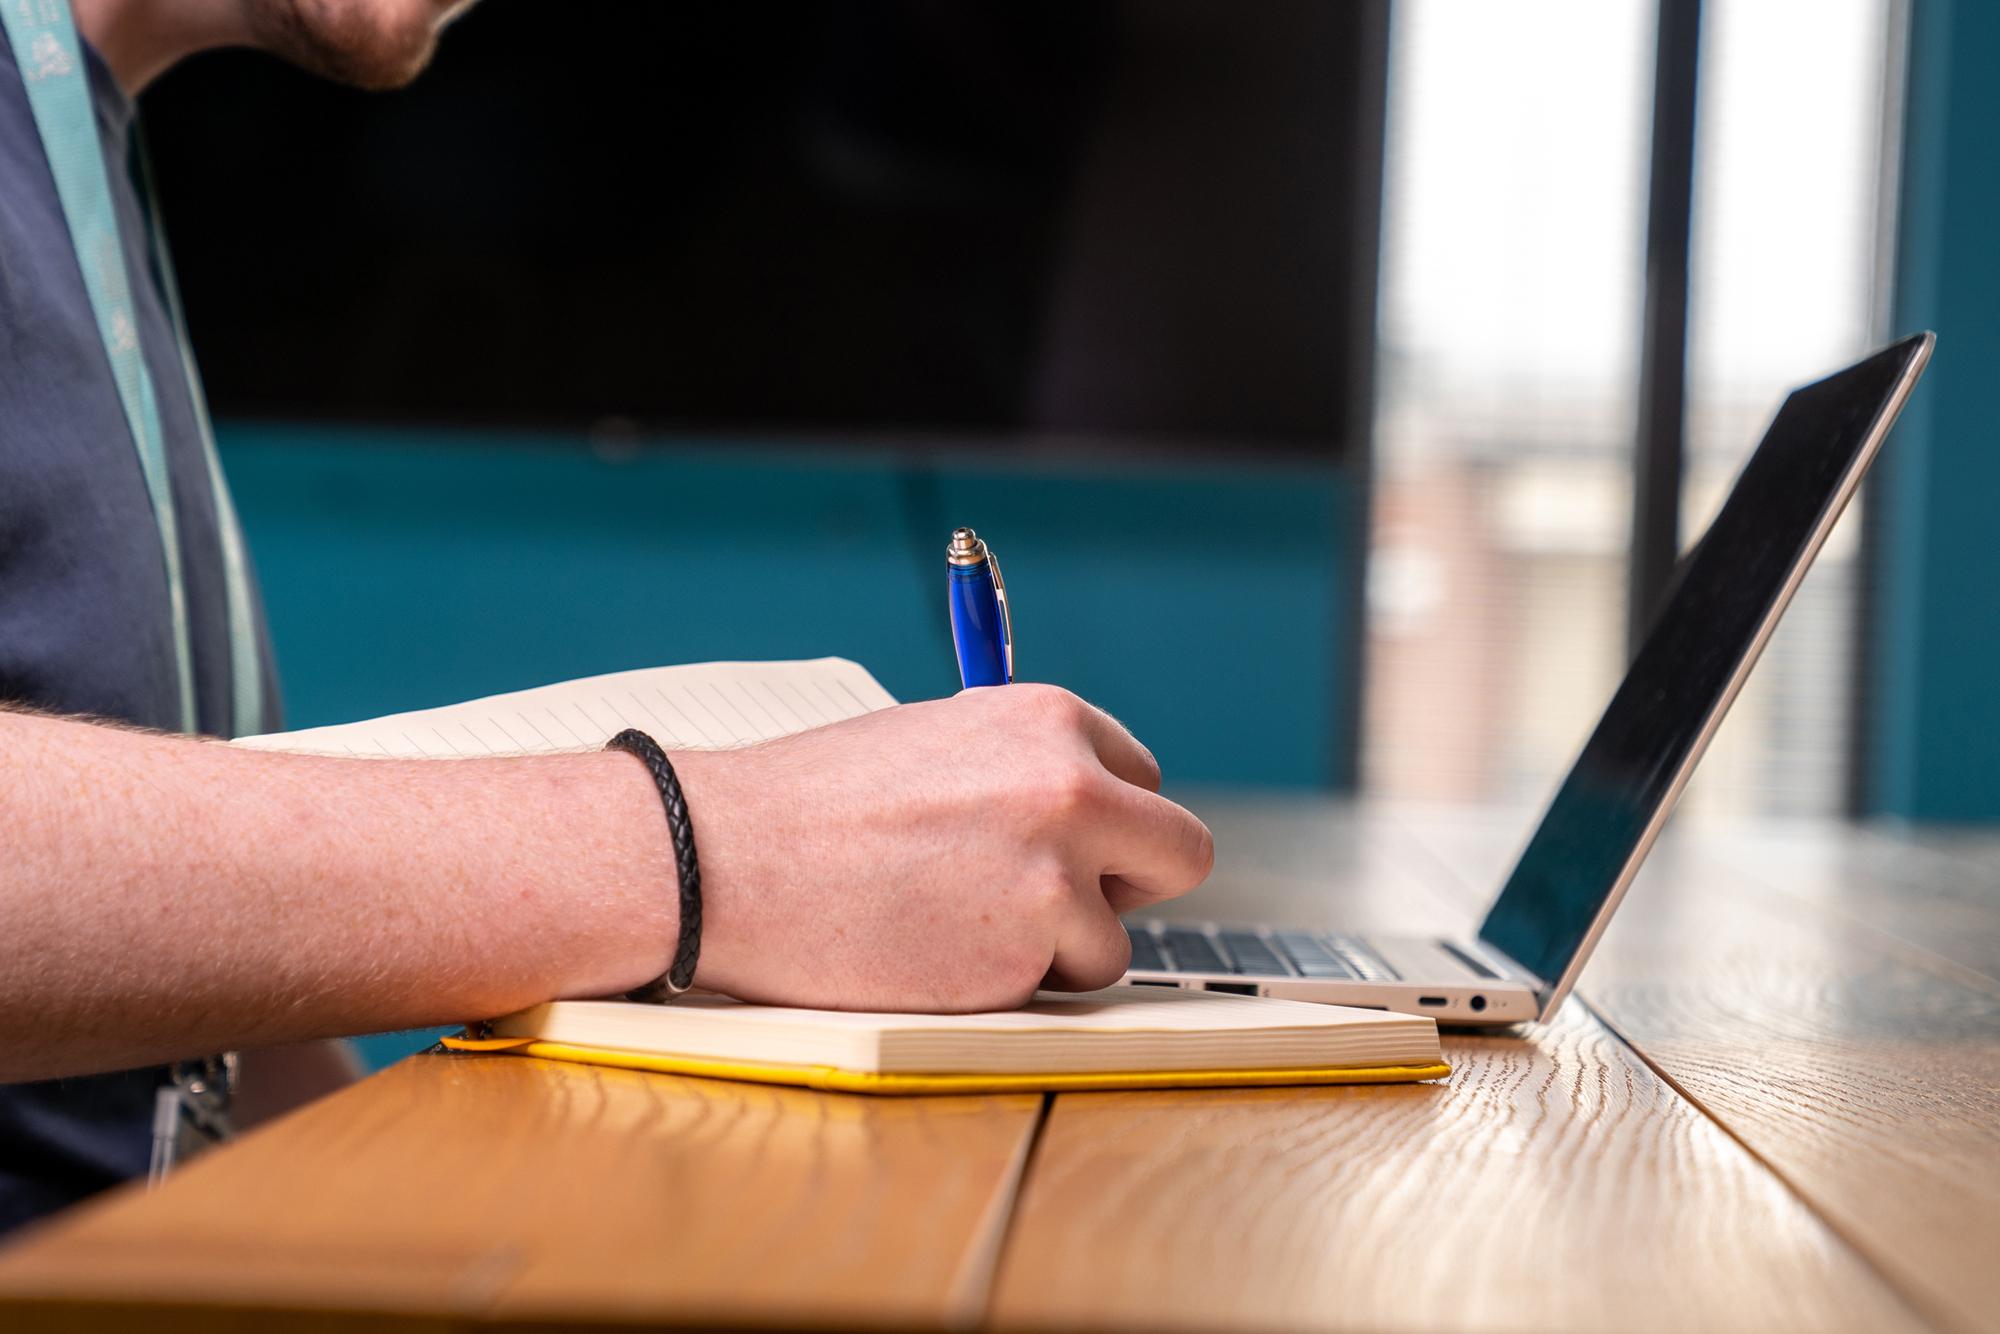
[994,1008,1922,1330]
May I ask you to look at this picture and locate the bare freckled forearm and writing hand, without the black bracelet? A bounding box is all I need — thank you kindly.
[0,686,1214,1080]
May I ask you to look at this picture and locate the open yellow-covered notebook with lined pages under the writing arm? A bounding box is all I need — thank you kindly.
[234,658,1450,1094]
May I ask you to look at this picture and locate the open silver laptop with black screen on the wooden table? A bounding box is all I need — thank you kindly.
[1126,334,1936,1024]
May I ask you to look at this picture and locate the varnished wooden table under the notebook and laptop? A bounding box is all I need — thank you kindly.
[0,802,2000,1330]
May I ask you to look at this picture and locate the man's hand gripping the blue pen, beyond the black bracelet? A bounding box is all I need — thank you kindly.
[662,686,1214,1010]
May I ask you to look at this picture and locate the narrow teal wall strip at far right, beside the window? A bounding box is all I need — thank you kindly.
[1864,0,2000,822]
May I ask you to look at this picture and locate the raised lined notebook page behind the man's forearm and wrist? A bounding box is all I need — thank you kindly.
[234,658,896,760]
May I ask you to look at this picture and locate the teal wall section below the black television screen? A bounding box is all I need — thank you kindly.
[220,434,1360,1060]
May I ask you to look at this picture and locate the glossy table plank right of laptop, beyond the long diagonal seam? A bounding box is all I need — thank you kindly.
[1586,842,2000,1330]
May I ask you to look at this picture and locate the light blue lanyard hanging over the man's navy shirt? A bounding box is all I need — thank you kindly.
[0,0,264,736]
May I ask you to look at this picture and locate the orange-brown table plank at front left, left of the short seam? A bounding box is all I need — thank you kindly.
[0,1056,1040,1330]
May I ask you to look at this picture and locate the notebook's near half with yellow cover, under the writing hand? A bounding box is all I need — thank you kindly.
[446,986,1450,1094]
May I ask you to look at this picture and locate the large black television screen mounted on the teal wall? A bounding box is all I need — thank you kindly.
[144,0,1386,456]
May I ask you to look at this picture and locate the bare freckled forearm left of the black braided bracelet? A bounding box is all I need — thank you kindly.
[0,714,676,1080]
